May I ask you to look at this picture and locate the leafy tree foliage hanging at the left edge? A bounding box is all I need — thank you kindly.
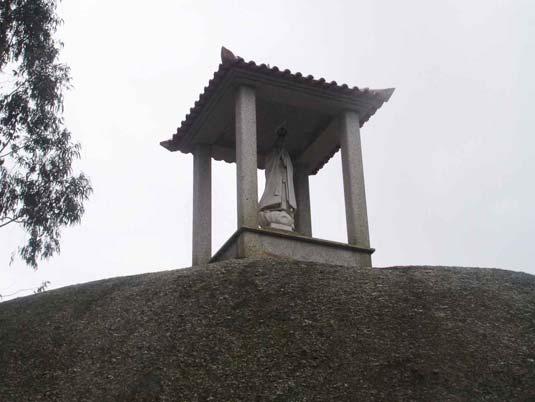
[0,0,92,268]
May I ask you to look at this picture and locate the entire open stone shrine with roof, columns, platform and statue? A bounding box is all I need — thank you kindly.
[160,47,394,267]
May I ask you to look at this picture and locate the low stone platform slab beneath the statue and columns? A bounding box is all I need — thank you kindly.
[210,226,375,267]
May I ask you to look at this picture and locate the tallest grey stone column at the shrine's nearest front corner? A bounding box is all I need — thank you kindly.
[236,86,258,229]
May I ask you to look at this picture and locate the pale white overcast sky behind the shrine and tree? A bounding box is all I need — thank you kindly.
[0,0,535,296]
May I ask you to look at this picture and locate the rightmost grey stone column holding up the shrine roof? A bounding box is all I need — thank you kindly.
[340,111,370,247]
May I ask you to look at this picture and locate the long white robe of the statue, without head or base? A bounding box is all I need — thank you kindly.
[259,148,297,212]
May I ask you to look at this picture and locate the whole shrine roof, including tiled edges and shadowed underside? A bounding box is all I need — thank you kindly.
[160,47,394,174]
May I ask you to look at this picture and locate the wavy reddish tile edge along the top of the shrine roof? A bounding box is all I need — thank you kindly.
[160,47,394,150]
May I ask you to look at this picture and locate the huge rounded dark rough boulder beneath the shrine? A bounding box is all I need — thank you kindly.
[0,259,535,401]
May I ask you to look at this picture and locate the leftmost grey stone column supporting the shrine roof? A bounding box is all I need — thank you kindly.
[192,145,212,265]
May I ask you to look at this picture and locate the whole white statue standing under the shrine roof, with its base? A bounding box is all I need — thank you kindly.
[259,128,297,231]
